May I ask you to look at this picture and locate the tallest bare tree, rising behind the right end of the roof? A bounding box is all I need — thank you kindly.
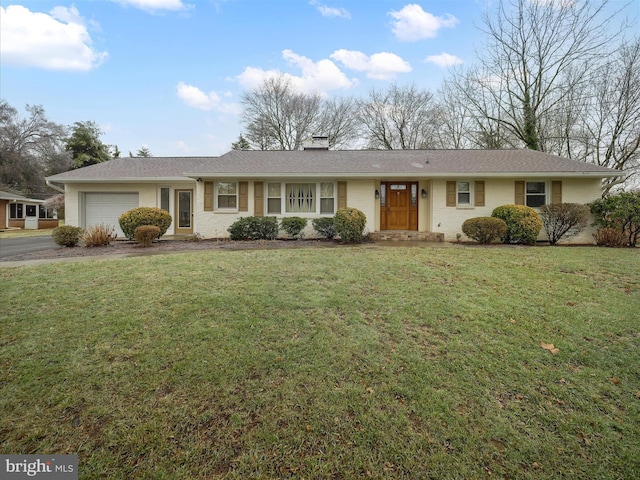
[462,0,617,150]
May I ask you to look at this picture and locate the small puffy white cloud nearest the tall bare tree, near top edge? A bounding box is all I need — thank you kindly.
[389,4,459,42]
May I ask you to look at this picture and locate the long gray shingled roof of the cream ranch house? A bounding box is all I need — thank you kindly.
[43,150,619,183]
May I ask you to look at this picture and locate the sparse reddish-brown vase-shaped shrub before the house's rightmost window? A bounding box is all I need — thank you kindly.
[540,203,589,245]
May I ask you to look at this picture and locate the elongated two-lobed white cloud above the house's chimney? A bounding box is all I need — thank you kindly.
[236,50,356,94]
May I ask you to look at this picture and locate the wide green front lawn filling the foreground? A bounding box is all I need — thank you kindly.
[0,247,640,479]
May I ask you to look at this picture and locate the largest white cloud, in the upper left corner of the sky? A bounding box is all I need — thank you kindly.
[0,5,108,71]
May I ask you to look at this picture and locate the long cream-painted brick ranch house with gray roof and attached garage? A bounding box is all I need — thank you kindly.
[47,144,619,243]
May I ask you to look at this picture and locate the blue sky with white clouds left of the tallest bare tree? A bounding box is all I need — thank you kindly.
[0,0,640,156]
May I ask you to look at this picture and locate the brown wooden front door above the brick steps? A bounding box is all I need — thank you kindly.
[380,182,418,230]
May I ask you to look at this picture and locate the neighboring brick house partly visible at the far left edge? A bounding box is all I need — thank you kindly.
[0,191,58,230]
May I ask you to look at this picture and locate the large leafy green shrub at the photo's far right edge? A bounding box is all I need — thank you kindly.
[589,191,640,247]
